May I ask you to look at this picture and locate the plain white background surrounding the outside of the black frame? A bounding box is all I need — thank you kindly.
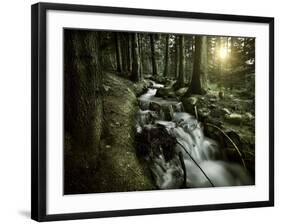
[0,0,276,224]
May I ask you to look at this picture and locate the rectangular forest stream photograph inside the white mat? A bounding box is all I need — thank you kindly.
[63,29,255,194]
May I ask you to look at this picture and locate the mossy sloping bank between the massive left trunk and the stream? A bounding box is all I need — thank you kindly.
[86,74,155,192]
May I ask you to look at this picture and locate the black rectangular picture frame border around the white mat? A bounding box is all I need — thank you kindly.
[31,3,274,221]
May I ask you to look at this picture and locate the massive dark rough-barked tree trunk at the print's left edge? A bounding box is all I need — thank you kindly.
[64,30,103,168]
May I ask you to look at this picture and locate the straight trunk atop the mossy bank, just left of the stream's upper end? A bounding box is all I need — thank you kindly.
[132,33,140,82]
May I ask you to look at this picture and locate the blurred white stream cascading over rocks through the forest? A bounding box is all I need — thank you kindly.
[136,82,253,189]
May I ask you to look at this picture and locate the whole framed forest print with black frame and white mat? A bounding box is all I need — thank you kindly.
[32,3,274,221]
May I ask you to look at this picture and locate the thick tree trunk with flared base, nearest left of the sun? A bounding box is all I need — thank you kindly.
[187,36,204,95]
